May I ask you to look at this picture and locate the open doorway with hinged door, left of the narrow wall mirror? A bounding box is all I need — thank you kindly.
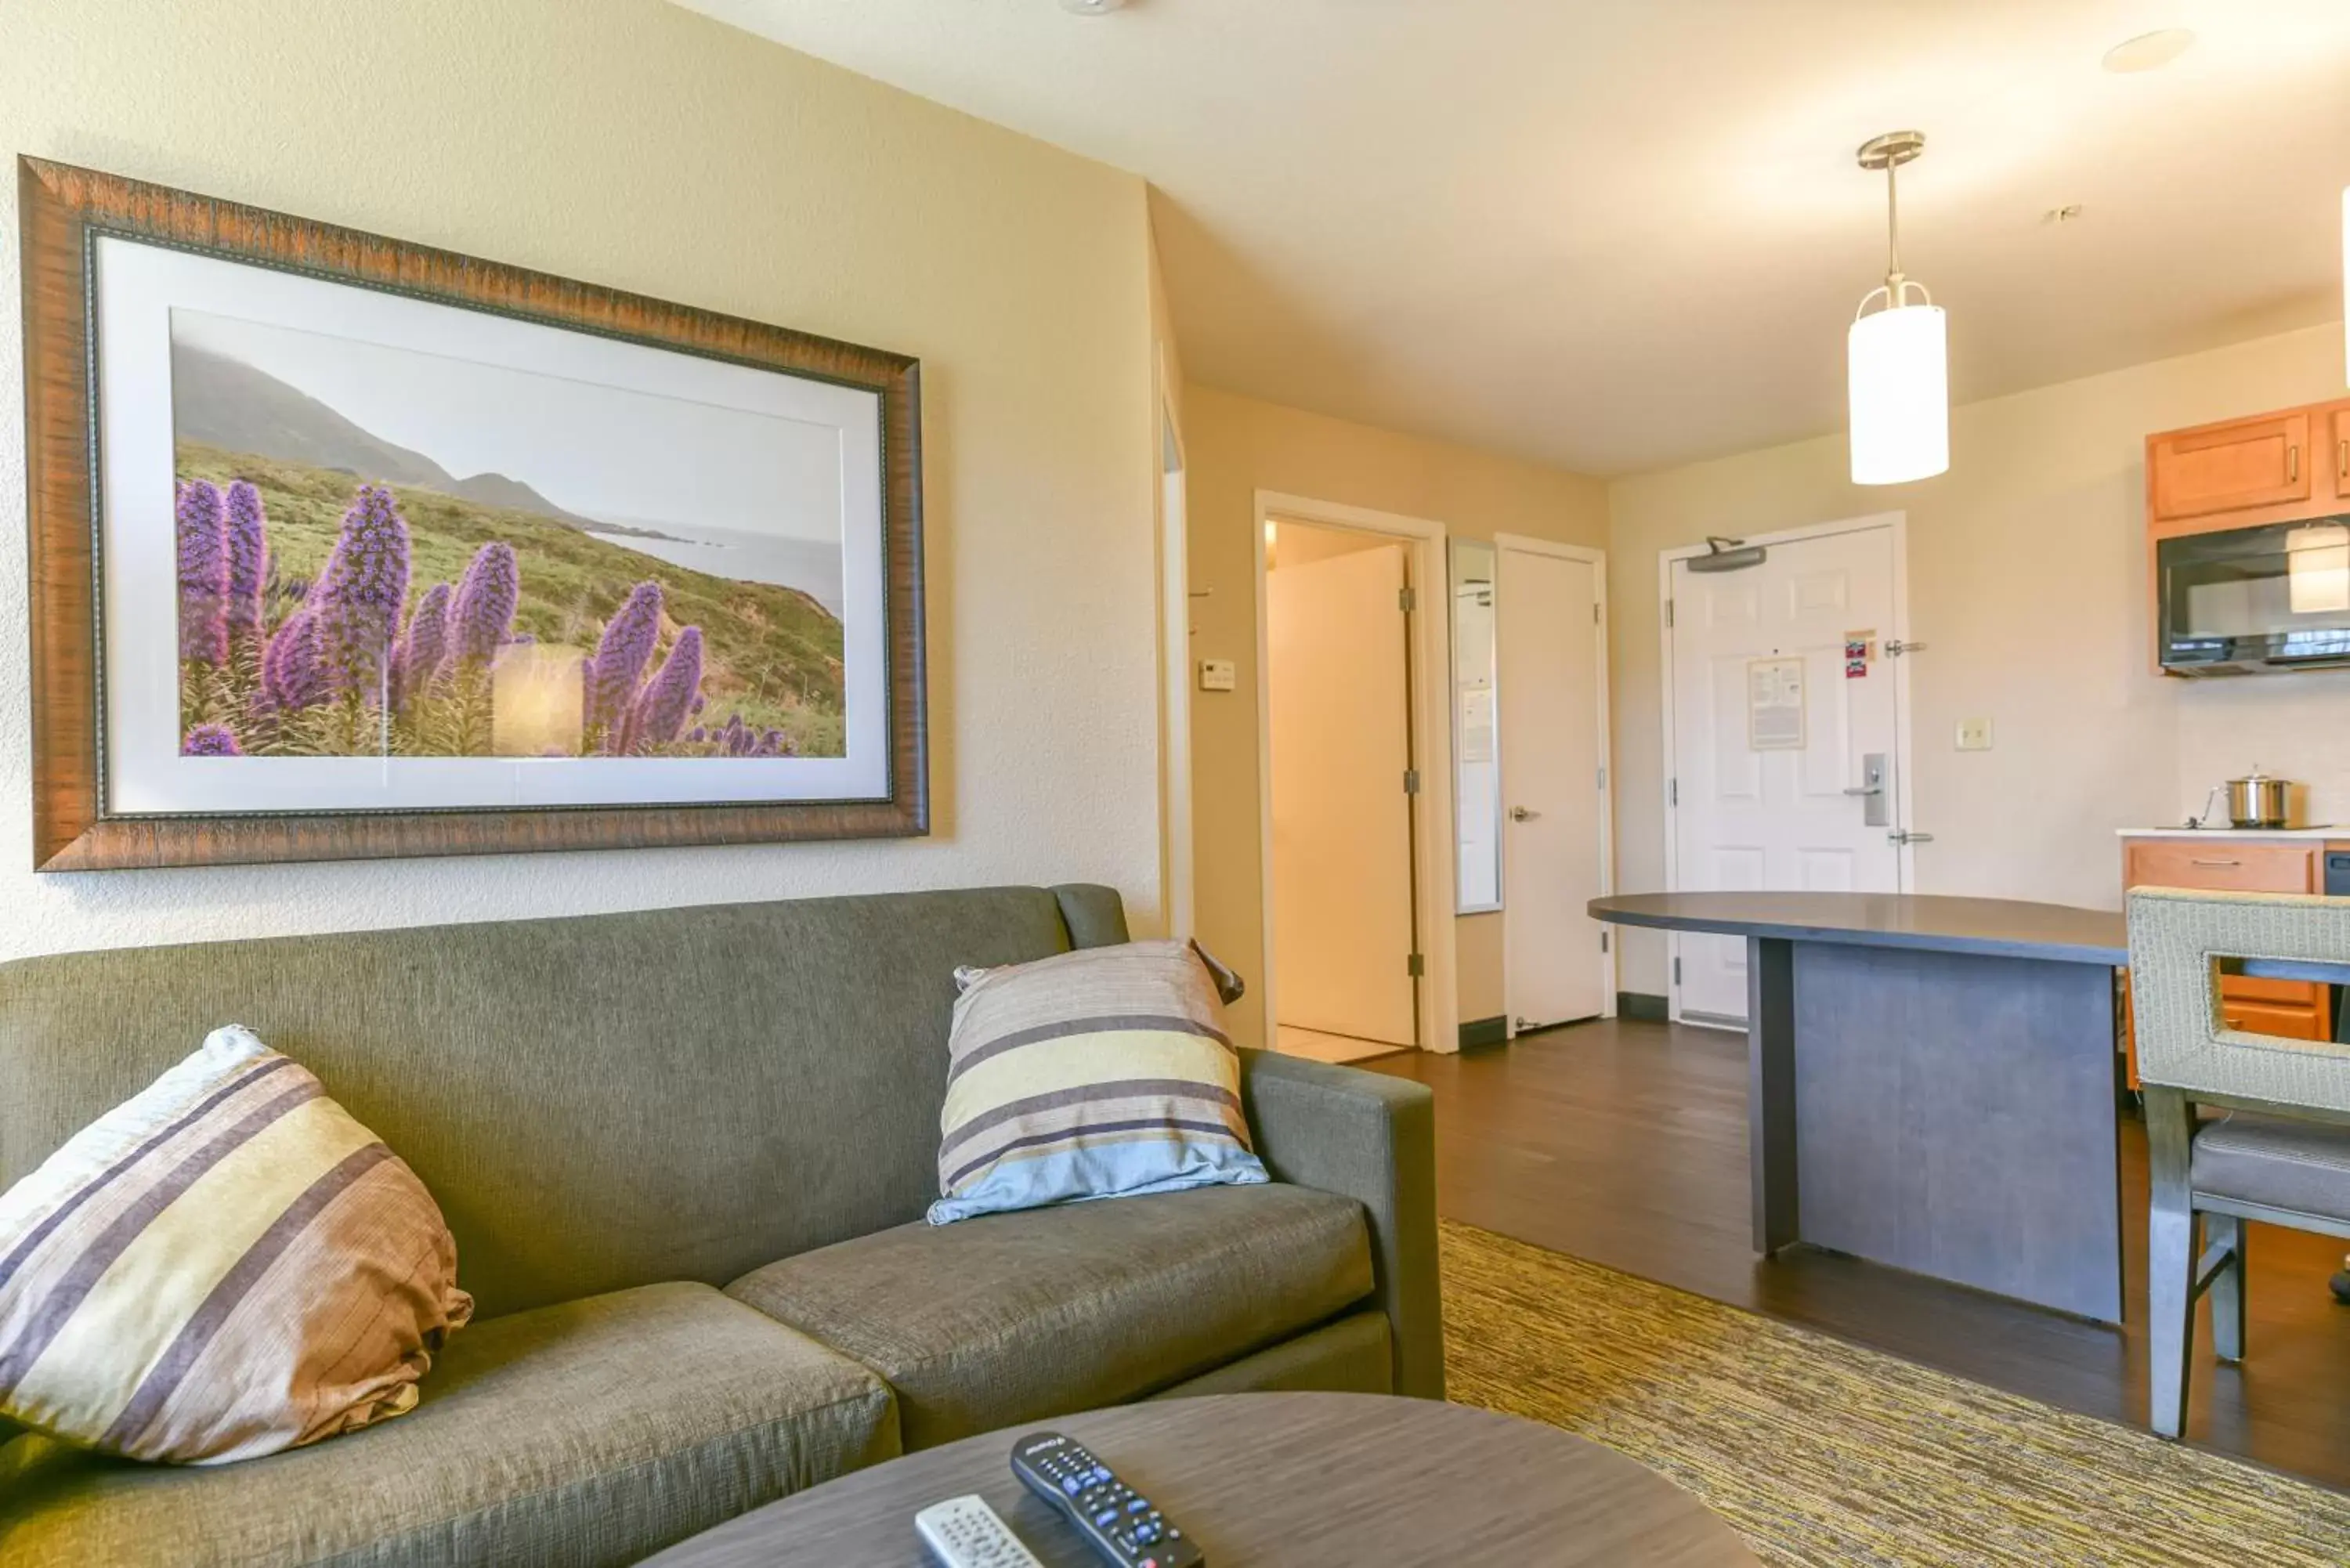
[1257,493,1459,1060]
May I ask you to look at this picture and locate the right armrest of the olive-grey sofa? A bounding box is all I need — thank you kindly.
[1241,1051,1445,1399]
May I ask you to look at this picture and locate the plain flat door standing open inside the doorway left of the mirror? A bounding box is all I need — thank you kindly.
[1264,543,1417,1046]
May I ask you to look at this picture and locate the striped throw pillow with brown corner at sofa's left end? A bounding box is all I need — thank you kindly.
[0,1028,472,1465]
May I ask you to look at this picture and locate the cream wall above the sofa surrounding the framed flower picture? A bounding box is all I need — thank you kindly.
[0,0,1159,957]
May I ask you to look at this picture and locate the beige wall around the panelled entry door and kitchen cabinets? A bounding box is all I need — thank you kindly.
[1610,327,2350,995]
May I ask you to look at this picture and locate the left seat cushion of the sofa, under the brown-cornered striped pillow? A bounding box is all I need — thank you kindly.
[0,1284,898,1568]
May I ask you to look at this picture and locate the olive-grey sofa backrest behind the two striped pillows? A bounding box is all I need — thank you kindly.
[0,889,1126,1317]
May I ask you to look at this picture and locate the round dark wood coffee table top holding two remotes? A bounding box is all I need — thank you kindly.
[651,1394,1758,1568]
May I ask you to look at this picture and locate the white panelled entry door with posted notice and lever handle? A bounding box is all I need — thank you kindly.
[1671,522,1901,1025]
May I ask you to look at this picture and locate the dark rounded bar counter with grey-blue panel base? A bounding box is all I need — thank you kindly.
[1591,894,2129,1324]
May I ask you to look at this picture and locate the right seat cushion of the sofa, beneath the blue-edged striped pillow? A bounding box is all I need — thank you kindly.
[726,1183,1372,1448]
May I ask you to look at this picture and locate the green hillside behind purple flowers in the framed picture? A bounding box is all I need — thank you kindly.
[176,439,846,757]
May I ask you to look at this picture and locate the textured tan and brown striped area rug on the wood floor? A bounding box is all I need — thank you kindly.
[1443,1223,2350,1568]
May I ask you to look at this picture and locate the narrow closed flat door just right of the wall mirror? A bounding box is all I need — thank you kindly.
[1495,545,1607,1030]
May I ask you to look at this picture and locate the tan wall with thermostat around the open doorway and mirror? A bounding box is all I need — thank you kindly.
[1184,383,1607,1044]
